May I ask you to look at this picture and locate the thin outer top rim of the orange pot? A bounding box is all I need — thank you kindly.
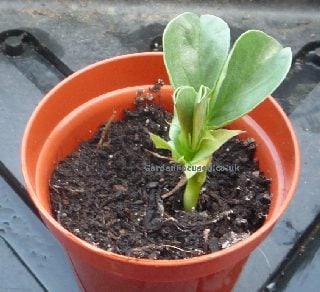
[21,52,300,267]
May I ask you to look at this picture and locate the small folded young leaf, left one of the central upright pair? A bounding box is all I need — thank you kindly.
[174,86,197,145]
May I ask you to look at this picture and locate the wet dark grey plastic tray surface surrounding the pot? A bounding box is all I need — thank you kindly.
[0,0,320,291]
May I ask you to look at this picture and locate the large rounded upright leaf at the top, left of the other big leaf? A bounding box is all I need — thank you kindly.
[163,12,230,91]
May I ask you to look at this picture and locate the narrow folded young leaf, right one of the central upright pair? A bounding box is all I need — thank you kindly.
[192,85,210,150]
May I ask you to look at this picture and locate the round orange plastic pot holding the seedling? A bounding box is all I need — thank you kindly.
[22,53,300,292]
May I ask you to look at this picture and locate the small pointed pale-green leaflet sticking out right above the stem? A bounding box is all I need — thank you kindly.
[191,129,243,164]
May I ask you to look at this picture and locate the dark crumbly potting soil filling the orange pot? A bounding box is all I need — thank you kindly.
[50,92,270,259]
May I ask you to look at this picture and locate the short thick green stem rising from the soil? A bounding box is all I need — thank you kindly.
[183,171,207,211]
